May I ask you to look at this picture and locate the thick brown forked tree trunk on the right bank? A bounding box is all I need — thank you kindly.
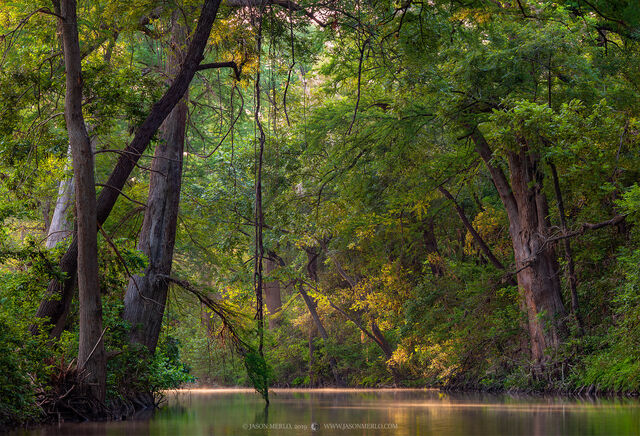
[471,127,565,363]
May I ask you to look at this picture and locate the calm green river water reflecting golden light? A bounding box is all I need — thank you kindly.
[12,389,640,436]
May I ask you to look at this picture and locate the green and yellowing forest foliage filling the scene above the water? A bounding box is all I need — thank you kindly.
[0,0,640,424]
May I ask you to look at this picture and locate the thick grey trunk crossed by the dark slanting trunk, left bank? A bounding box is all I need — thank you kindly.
[124,14,187,353]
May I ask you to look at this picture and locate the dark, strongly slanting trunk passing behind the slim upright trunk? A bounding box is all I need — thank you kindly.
[30,0,220,336]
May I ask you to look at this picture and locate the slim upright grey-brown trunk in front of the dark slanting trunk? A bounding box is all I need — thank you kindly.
[60,0,106,401]
